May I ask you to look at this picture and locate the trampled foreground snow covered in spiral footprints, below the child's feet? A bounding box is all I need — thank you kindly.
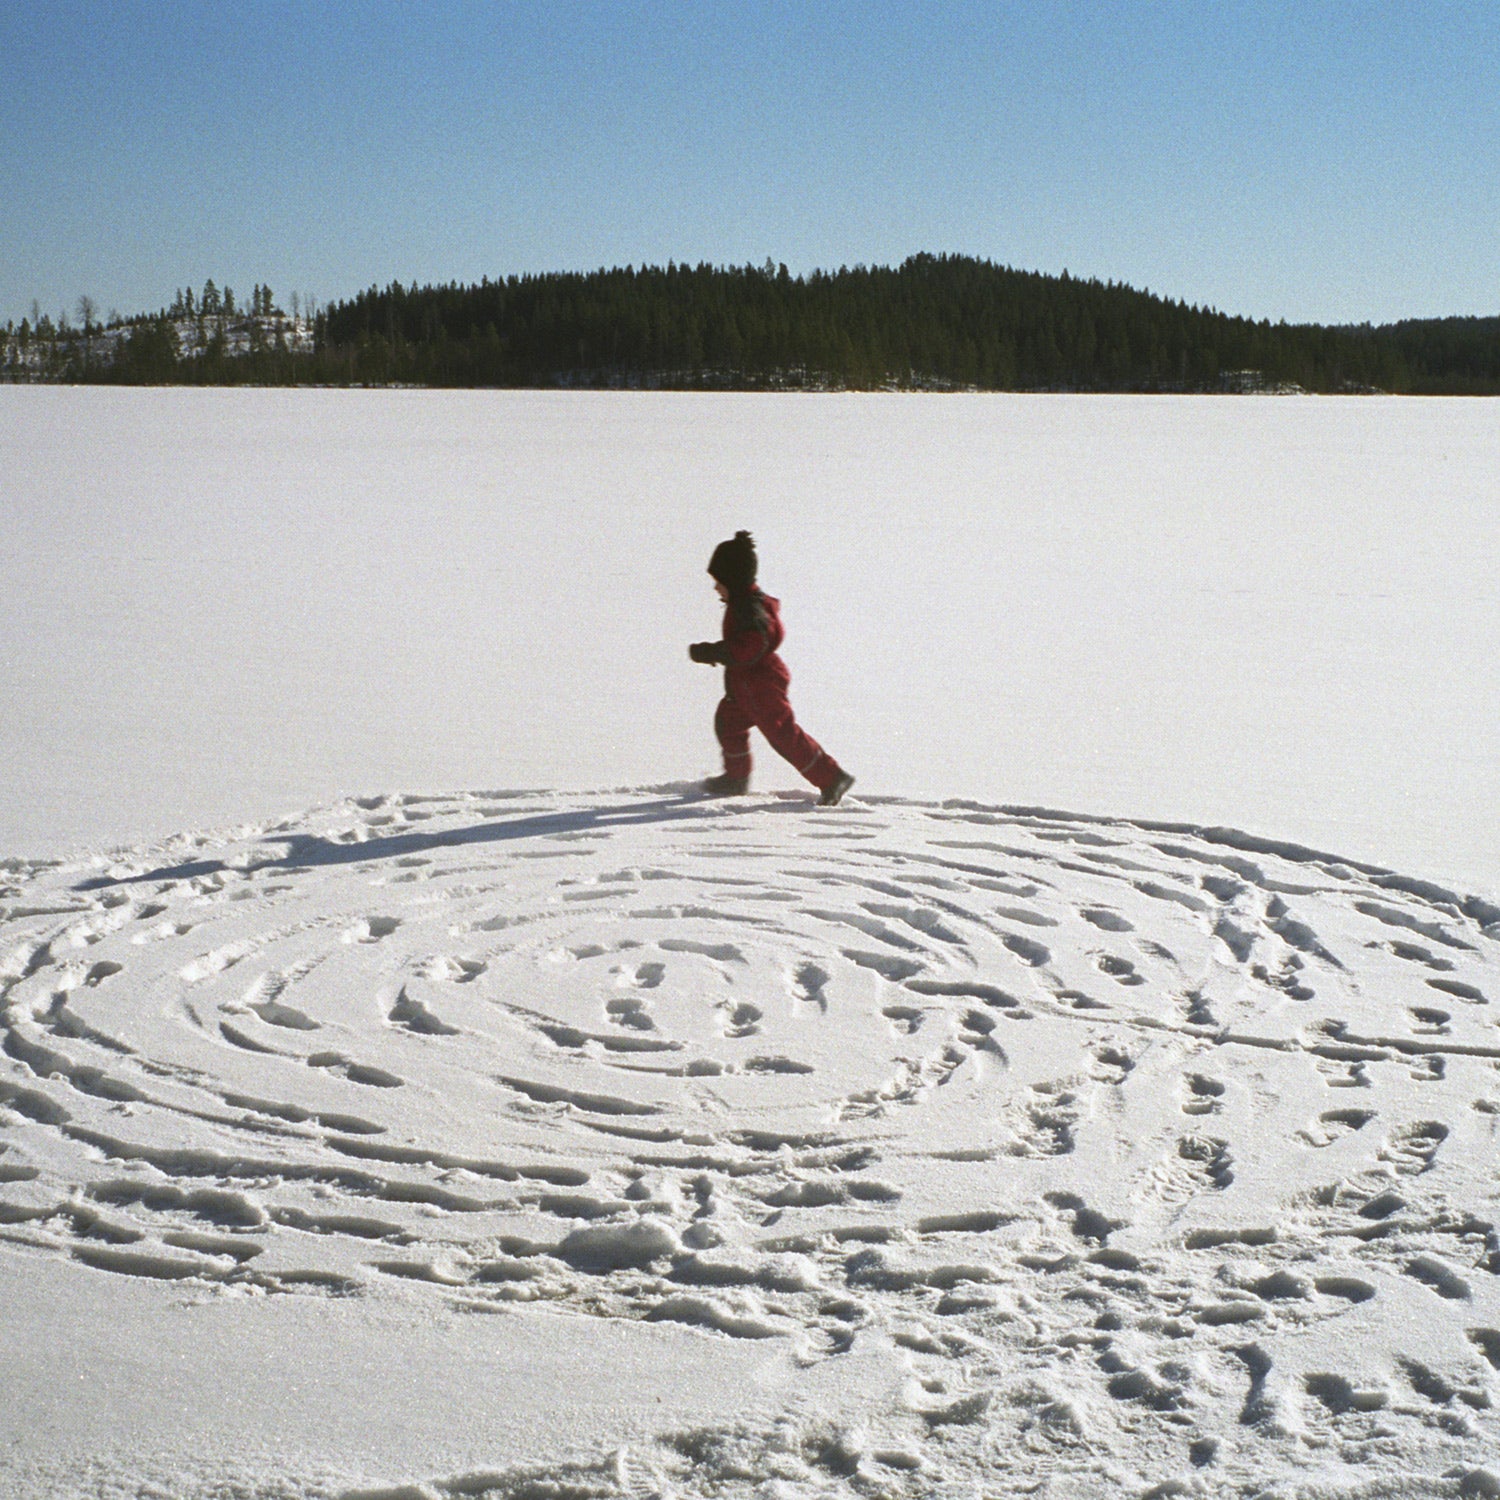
[0,786,1500,1500]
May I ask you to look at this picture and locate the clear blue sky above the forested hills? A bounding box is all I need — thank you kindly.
[0,0,1500,323]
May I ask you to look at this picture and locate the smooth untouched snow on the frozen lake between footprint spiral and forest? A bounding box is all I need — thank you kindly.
[0,387,1500,894]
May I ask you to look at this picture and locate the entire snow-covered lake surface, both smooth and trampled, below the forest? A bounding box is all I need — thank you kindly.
[0,389,1500,1500]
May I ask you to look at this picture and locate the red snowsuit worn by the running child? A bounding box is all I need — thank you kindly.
[714,588,843,792]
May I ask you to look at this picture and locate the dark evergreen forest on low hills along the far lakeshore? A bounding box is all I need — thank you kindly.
[0,255,1500,395]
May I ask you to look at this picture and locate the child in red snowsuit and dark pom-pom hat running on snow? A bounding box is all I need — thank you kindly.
[687,531,854,807]
